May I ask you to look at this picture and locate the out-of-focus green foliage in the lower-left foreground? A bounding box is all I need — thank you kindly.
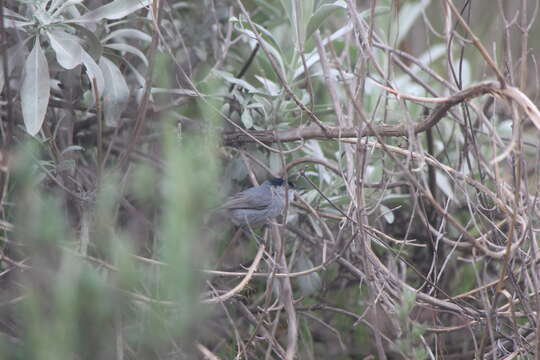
[0,120,218,359]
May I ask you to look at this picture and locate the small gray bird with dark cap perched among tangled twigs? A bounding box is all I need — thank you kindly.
[220,178,294,227]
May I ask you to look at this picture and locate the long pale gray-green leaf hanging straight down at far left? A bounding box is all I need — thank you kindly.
[21,37,51,136]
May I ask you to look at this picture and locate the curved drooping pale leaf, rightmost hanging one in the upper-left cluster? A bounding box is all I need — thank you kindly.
[99,56,129,126]
